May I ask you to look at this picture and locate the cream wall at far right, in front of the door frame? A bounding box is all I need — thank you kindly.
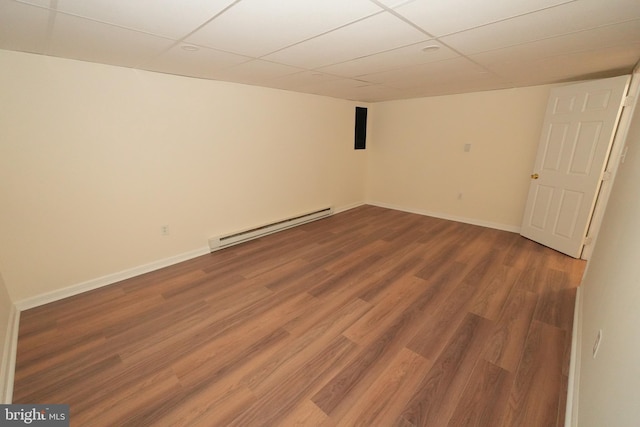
[577,76,640,427]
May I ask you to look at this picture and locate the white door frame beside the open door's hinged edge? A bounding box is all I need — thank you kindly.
[580,68,640,260]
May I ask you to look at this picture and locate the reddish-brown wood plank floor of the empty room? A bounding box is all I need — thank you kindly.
[14,206,585,427]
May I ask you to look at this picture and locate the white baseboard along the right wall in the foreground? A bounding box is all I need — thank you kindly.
[564,287,582,427]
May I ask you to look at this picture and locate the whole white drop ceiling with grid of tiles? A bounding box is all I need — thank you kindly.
[0,0,640,102]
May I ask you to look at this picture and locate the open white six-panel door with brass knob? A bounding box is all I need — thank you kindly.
[521,76,630,258]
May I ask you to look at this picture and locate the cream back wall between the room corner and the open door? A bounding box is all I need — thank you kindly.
[367,86,550,230]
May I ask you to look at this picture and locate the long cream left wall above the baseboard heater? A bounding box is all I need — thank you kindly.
[0,51,366,302]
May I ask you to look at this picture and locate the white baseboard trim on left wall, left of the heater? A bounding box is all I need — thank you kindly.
[15,247,211,311]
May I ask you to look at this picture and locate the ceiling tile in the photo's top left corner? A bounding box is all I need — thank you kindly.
[0,0,54,53]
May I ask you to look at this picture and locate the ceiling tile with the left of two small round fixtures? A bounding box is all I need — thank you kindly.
[139,44,251,78]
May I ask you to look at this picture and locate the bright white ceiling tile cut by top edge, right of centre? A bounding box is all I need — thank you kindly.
[396,0,575,36]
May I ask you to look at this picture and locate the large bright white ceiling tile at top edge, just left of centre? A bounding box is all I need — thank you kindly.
[186,0,382,57]
